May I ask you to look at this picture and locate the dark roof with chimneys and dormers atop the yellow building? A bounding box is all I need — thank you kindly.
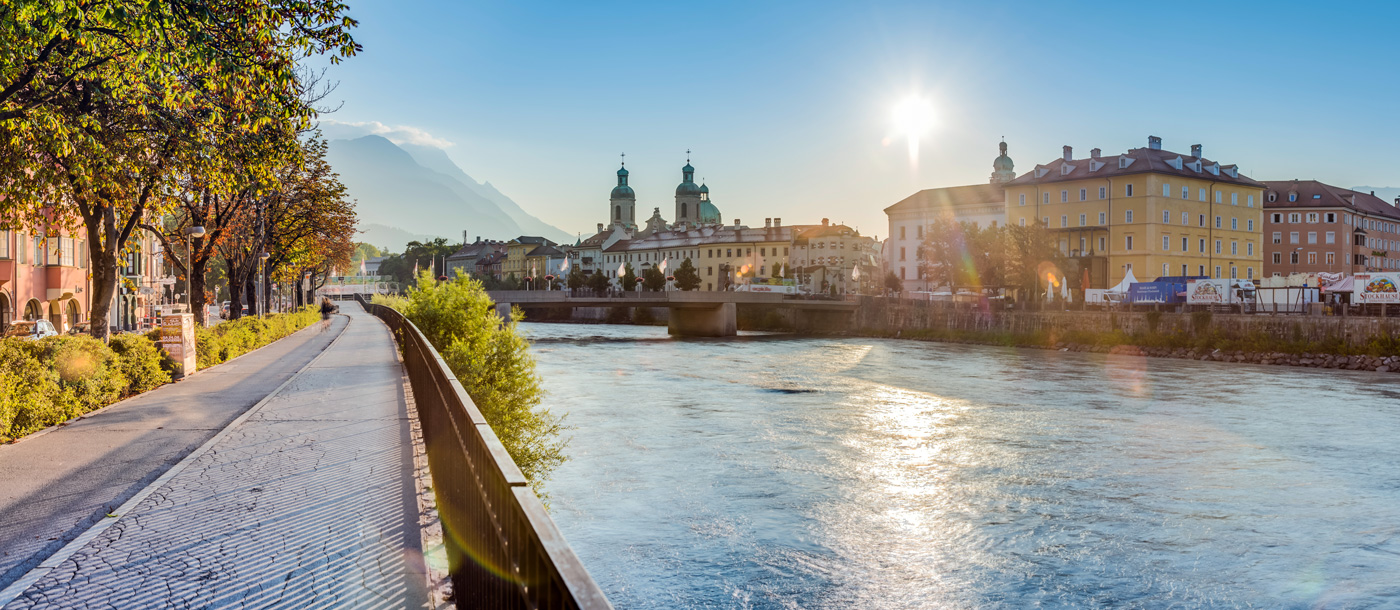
[1007,147,1264,187]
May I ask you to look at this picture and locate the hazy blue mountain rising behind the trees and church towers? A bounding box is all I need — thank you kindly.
[326,136,573,252]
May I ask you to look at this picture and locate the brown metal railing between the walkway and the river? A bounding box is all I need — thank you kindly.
[356,295,612,610]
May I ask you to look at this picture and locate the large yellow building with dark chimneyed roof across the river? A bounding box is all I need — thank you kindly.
[1007,136,1264,288]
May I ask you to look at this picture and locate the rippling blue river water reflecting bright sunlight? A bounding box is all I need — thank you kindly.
[522,323,1400,609]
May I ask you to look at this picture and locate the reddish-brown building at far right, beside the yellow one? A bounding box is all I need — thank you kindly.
[1264,180,1400,276]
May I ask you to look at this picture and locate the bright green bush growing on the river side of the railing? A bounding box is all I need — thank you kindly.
[400,276,565,495]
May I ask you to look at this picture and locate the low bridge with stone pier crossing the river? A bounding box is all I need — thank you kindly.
[490,290,857,337]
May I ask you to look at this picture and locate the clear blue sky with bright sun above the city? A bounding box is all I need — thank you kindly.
[312,0,1400,238]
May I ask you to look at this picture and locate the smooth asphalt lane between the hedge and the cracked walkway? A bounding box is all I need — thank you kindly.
[0,316,346,590]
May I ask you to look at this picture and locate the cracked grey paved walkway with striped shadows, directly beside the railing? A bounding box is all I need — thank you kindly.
[4,304,426,610]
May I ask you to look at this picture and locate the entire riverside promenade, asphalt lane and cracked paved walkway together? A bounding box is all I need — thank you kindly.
[0,302,427,610]
